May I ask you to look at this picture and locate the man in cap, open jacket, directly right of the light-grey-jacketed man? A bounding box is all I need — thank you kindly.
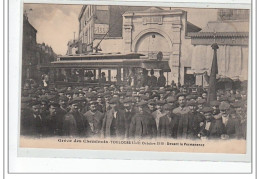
[101,97,125,138]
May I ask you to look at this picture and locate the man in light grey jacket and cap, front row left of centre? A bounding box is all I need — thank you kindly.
[84,101,104,137]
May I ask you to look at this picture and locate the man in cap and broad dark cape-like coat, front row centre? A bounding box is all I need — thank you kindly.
[129,101,157,139]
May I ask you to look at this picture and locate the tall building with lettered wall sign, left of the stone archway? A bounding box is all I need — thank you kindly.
[78,5,122,53]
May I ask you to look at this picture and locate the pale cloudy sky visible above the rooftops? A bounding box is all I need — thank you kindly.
[24,4,217,55]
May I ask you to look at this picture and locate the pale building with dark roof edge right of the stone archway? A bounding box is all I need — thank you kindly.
[189,9,249,86]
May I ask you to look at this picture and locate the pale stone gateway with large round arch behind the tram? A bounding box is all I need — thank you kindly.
[123,7,201,84]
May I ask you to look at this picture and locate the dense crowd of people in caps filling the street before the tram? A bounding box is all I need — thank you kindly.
[20,70,247,140]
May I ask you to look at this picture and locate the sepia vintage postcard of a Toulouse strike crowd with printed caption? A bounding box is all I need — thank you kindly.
[19,3,251,158]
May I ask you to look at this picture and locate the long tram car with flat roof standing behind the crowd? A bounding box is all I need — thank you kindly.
[41,53,171,88]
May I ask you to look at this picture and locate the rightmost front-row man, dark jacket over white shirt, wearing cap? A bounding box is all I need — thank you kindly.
[219,102,240,139]
